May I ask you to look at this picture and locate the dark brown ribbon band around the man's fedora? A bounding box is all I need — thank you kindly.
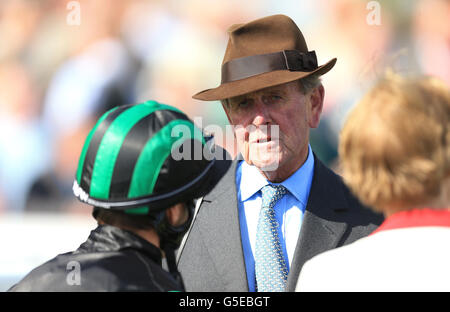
[222,50,317,83]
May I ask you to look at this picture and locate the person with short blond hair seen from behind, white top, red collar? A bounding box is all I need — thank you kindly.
[296,74,450,291]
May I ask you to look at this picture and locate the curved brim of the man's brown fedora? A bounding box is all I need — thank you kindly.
[192,58,337,101]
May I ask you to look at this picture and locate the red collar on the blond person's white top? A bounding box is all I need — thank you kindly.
[372,208,450,234]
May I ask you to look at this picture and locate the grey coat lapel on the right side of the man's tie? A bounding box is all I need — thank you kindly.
[287,157,348,291]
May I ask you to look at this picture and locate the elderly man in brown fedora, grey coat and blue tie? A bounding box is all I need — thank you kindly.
[178,15,381,291]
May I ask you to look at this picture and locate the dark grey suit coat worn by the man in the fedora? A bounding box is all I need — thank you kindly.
[178,157,382,292]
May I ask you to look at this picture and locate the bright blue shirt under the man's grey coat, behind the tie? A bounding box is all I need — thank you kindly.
[236,146,314,292]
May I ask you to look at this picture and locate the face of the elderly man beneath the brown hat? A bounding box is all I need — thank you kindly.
[224,81,324,182]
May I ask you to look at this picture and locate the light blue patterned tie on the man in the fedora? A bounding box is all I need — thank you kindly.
[255,185,288,292]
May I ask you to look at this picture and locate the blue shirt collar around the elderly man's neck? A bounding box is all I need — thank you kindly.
[239,145,314,206]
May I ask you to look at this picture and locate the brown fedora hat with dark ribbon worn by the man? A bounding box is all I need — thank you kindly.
[193,15,336,101]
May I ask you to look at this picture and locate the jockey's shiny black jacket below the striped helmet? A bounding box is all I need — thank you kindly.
[8,225,184,292]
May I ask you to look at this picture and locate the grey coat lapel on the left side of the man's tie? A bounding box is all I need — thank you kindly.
[199,160,248,291]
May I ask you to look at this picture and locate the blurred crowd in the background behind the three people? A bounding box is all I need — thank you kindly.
[0,0,450,215]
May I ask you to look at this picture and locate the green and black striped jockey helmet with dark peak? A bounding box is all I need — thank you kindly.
[73,101,220,214]
